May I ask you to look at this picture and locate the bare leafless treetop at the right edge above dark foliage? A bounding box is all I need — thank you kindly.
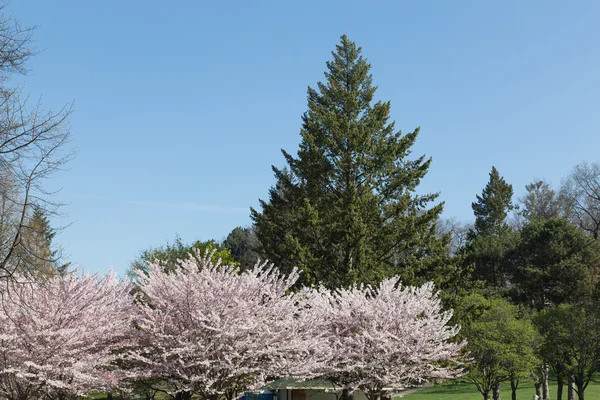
[560,162,600,239]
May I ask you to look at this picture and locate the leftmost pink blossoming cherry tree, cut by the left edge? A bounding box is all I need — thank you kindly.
[0,273,133,400]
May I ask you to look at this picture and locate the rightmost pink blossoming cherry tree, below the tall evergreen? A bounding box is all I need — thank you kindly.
[306,277,463,400]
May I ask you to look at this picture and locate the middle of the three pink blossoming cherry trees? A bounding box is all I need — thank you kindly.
[133,254,327,399]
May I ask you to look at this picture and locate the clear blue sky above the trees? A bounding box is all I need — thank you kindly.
[6,0,600,273]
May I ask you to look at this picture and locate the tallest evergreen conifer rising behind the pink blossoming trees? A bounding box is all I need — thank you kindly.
[252,36,449,287]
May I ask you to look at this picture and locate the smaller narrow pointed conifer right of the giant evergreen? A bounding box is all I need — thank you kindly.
[464,167,517,289]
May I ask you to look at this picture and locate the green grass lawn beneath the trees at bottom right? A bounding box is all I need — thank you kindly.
[402,382,600,400]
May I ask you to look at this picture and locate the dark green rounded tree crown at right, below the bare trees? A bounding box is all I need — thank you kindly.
[510,218,600,309]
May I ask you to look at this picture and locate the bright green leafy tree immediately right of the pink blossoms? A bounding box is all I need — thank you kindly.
[455,294,537,400]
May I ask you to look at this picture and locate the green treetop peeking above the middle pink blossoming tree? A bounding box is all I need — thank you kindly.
[127,236,238,280]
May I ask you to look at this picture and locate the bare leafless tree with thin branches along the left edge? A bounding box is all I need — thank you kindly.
[0,4,73,279]
